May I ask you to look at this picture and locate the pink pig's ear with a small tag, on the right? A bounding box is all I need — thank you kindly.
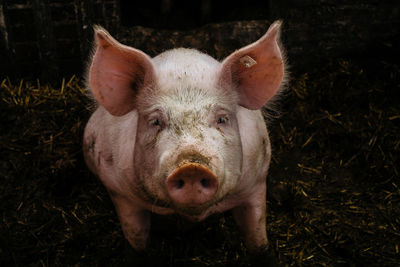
[221,21,284,110]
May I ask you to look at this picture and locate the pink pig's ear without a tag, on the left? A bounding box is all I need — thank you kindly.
[89,27,154,116]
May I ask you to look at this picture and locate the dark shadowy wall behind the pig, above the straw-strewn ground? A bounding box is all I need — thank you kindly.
[0,0,400,79]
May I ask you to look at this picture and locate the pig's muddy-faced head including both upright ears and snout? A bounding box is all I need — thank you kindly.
[89,22,284,217]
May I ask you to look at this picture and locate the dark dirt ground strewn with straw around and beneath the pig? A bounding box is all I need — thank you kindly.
[0,58,400,266]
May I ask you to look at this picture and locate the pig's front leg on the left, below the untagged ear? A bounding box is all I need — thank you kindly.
[111,194,150,251]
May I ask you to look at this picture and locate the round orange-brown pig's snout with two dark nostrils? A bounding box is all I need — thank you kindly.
[166,163,218,206]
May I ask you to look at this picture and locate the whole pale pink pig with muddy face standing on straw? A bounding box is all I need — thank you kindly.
[83,21,286,264]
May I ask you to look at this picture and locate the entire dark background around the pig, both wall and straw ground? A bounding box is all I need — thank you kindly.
[0,0,400,267]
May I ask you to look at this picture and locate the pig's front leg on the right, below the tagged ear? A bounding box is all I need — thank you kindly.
[233,183,278,266]
